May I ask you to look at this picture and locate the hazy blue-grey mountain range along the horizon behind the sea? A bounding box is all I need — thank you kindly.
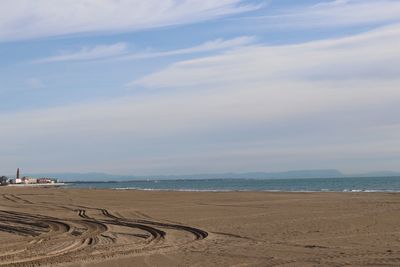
[25,170,400,182]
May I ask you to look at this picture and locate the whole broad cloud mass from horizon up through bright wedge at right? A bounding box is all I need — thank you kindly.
[0,25,400,174]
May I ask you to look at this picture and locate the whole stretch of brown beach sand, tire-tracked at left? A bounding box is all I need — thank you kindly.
[0,187,400,267]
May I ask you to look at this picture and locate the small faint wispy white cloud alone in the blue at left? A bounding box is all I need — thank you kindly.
[35,43,128,63]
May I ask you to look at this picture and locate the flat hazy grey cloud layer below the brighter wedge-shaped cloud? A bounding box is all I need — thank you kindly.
[0,78,400,174]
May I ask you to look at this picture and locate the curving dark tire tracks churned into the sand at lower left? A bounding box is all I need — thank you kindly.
[0,201,208,267]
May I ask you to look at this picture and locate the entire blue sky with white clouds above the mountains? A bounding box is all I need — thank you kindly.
[0,0,400,175]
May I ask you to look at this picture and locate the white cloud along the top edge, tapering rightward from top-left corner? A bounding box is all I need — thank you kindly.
[0,0,259,41]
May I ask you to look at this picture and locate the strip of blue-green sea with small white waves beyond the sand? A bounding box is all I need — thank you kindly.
[68,177,400,192]
